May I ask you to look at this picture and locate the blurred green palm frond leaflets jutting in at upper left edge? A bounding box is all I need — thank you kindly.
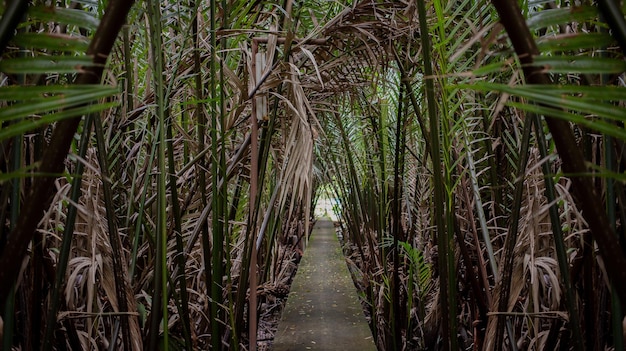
[0,6,118,141]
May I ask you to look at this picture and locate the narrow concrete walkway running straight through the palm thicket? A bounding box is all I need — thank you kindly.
[272,220,376,351]
